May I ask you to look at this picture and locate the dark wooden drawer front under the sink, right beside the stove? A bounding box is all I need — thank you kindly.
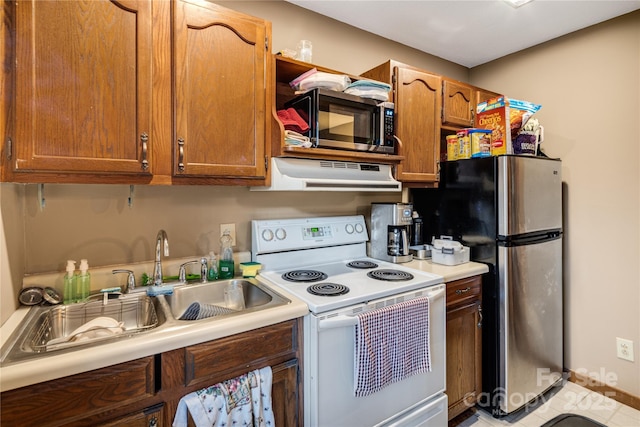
[185,320,298,386]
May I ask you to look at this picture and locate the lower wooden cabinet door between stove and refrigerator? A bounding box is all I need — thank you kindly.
[446,301,482,419]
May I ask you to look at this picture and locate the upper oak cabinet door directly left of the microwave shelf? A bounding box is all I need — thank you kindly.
[174,1,267,178]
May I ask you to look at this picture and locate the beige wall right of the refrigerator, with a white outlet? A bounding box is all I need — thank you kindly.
[470,12,640,396]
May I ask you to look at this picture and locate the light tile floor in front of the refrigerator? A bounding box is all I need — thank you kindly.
[457,382,640,427]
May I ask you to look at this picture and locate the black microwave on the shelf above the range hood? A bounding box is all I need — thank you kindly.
[285,88,395,154]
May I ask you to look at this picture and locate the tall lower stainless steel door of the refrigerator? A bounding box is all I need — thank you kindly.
[496,238,563,414]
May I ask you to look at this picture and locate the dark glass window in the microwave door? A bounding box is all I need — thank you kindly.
[318,98,375,144]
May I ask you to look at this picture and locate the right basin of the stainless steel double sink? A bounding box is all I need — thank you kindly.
[160,279,290,321]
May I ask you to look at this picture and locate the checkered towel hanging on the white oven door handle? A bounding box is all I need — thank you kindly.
[354,297,431,397]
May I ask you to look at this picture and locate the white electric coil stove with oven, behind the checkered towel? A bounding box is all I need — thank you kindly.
[251,215,447,427]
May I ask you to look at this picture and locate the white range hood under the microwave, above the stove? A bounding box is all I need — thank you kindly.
[251,157,402,192]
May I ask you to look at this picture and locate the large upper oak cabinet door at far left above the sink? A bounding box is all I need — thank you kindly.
[12,0,152,175]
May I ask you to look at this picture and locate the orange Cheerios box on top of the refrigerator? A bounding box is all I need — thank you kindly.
[476,96,512,156]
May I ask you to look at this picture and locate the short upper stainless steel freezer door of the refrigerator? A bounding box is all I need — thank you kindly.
[496,156,562,236]
